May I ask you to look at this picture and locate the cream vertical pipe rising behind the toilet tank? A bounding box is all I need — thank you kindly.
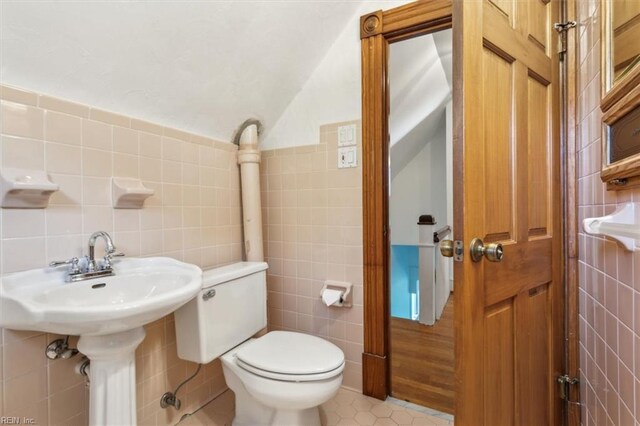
[238,125,264,262]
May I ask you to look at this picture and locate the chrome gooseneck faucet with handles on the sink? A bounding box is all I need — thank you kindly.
[49,231,124,282]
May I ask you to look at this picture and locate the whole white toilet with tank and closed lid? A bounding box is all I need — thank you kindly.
[175,262,344,426]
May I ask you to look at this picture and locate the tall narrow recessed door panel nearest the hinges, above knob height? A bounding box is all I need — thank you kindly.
[527,75,551,237]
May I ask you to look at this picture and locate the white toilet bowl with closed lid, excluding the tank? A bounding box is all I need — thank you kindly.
[222,331,344,426]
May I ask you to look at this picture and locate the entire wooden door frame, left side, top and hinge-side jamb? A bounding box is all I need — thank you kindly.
[360,0,580,425]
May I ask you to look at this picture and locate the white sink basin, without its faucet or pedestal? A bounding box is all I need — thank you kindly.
[0,257,202,336]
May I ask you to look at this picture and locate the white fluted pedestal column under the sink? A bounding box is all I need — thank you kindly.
[78,327,145,426]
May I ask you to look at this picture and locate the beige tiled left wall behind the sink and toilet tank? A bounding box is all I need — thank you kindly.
[0,86,242,425]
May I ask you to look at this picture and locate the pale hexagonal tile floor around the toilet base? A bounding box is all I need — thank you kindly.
[179,389,453,426]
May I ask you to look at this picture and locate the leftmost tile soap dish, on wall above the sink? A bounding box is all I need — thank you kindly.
[0,168,59,209]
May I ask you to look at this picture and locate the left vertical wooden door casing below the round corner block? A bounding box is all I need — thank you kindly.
[362,30,389,399]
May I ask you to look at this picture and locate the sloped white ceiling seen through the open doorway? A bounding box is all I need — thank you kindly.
[389,29,453,178]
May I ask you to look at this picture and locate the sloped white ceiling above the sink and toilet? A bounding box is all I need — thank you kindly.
[0,0,362,141]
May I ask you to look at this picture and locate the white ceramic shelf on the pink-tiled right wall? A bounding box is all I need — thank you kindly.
[582,203,640,251]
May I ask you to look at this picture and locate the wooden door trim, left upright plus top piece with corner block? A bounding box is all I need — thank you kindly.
[360,0,452,399]
